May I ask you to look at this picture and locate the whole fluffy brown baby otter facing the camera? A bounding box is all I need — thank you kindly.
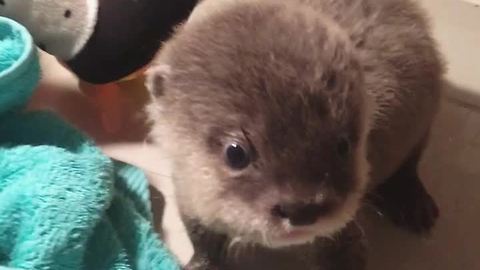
[148,0,443,270]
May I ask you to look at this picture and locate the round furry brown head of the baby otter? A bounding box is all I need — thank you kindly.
[148,1,367,247]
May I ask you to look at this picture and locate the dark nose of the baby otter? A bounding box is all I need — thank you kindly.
[272,202,331,226]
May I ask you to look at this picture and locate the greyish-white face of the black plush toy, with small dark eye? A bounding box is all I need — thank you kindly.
[0,0,98,60]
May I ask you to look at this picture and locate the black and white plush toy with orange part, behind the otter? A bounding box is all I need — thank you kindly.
[0,0,198,131]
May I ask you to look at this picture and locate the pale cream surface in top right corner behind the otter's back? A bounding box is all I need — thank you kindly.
[420,0,480,105]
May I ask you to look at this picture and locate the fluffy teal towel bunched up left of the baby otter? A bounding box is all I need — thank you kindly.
[0,17,179,270]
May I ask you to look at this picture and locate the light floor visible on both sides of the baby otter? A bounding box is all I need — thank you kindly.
[30,0,480,270]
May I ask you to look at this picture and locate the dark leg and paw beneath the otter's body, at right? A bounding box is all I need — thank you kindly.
[372,139,439,234]
